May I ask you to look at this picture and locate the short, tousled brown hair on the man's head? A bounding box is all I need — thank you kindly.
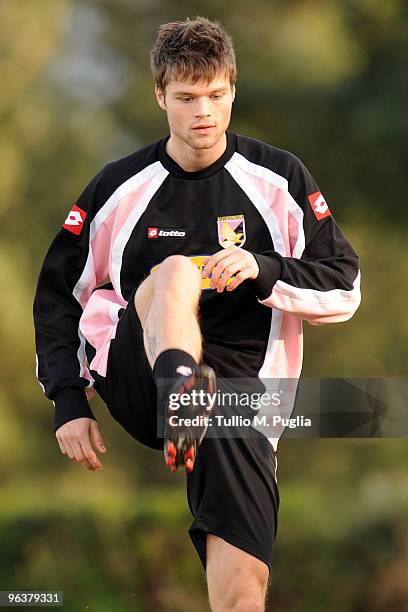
[150,17,237,92]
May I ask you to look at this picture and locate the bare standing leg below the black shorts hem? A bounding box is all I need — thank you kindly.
[206,533,269,612]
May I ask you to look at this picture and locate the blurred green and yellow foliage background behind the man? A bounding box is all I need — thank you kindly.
[0,0,408,612]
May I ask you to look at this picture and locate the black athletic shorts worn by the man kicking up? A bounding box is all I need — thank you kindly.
[86,290,279,570]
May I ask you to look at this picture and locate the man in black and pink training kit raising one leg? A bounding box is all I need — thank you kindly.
[34,18,360,610]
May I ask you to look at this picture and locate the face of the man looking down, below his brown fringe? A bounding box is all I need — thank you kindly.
[155,76,235,149]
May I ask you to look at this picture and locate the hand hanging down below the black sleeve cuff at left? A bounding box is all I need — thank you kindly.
[55,417,106,472]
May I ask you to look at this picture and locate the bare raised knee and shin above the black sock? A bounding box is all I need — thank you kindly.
[135,255,202,368]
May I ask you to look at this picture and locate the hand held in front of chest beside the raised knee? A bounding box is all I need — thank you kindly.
[202,246,259,293]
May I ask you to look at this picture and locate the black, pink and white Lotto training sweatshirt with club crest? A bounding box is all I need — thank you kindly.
[34,132,360,429]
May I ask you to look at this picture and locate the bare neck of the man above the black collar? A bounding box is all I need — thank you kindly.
[166,132,227,172]
